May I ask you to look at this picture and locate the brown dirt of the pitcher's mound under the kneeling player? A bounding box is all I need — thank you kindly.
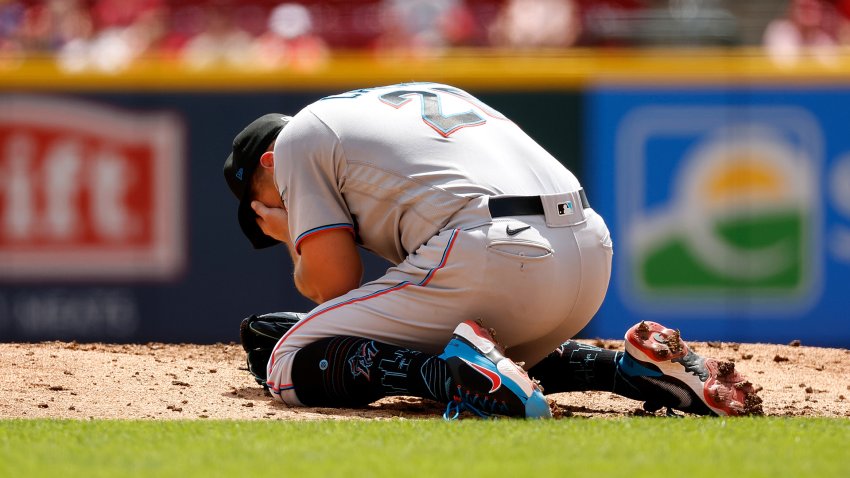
[0,341,850,420]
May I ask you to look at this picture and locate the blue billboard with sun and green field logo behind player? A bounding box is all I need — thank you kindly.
[585,86,850,346]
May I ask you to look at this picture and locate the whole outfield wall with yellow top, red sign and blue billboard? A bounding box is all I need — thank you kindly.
[0,51,850,346]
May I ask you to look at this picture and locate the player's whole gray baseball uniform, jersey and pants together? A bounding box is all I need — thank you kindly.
[268,83,612,405]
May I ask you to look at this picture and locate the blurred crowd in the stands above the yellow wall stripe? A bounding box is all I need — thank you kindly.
[0,0,850,71]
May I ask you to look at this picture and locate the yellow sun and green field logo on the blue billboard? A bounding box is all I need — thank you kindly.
[629,124,816,297]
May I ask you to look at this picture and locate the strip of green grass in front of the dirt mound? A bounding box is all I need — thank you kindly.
[0,418,850,478]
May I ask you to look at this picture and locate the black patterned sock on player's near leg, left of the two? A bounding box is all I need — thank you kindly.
[292,337,451,407]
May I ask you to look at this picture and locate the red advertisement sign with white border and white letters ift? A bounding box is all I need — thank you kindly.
[0,95,185,280]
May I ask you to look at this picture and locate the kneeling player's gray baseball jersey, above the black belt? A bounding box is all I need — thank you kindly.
[274,83,579,264]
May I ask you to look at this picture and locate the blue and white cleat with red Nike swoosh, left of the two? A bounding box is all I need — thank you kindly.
[440,321,552,420]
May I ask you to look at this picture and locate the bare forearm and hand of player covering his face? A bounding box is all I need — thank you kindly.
[251,201,363,304]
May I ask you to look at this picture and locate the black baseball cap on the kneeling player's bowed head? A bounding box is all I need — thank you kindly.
[224,113,290,249]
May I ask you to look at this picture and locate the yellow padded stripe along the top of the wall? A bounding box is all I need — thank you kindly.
[0,49,850,91]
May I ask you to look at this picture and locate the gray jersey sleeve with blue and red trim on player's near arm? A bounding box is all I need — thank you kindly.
[274,109,354,254]
